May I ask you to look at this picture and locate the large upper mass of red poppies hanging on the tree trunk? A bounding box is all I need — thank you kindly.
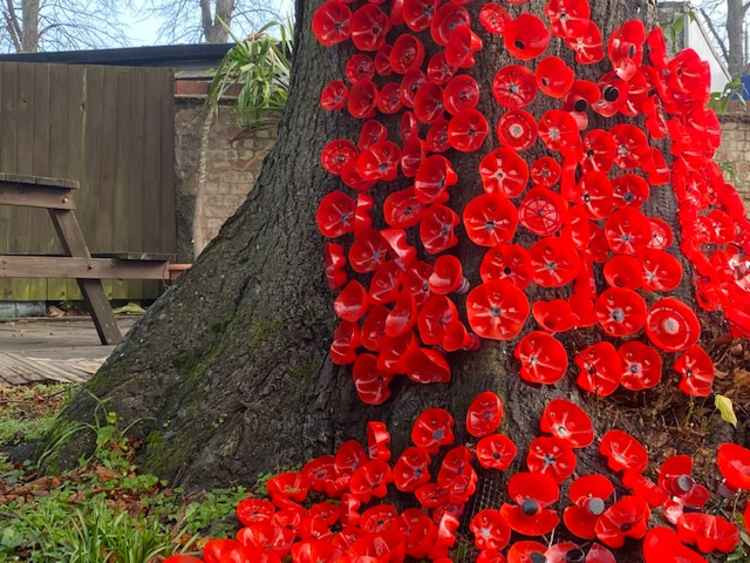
[312,0,750,404]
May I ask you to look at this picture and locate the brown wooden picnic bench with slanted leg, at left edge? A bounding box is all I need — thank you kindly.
[0,173,190,344]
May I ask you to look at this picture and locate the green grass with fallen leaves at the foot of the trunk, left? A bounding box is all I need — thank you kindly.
[0,385,246,563]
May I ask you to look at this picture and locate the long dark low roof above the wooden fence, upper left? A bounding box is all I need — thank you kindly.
[0,43,234,69]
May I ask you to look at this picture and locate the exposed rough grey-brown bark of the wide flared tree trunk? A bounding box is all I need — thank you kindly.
[48,0,748,532]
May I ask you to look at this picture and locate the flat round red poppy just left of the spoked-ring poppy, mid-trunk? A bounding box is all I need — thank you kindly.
[464,193,518,247]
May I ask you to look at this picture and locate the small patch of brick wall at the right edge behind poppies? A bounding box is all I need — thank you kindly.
[715,111,750,212]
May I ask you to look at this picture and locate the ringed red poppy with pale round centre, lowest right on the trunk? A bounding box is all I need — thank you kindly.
[646,297,701,352]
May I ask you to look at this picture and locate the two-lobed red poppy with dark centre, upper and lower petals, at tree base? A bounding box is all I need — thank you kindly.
[500,472,560,536]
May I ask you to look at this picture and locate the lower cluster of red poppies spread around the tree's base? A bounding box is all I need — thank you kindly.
[165,391,750,563]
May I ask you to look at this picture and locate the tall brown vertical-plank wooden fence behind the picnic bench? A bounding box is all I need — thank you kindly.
[0,62,176,301]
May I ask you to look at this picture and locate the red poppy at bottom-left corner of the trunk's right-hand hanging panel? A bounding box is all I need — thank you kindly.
[514,331,568,385]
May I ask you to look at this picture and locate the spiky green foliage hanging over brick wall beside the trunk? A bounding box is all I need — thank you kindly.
[208,22,292,129]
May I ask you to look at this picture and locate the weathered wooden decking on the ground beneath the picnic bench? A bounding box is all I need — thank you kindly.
[0,317,136,385]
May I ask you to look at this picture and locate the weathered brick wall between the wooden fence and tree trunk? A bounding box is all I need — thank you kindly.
[175,95,275,262]
